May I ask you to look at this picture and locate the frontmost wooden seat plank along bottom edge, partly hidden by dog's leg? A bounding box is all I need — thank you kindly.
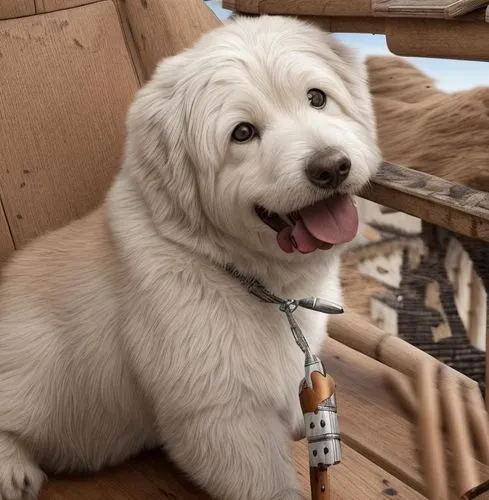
[39,441,424,500]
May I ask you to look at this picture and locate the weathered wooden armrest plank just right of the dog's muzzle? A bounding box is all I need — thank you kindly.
[361,162,489,241]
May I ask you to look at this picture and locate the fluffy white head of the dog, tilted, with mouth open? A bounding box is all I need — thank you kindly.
[128,16,380,256]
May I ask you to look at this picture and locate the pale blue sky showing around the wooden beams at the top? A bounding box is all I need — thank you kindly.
[207,0,489,92]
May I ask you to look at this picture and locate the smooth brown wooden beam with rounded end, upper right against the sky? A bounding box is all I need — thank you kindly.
[385,18,489,61]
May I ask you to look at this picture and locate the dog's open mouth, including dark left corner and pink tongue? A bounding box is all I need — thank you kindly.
[255,194,358,254]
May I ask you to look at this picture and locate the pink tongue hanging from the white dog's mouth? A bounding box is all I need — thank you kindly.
[277,195,358,253]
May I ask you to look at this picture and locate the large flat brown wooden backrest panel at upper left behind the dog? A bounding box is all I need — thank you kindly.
[0,1,138,248]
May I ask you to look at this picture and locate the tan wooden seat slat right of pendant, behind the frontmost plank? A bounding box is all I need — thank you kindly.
[324,339,423,492]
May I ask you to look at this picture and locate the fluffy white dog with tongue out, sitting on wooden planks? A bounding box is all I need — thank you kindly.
[0,17,380,500]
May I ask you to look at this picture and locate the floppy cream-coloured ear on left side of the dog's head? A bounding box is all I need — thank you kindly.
[125,52,206,233]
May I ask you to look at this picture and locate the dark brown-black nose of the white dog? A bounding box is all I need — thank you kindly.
[306,148,351,189]
